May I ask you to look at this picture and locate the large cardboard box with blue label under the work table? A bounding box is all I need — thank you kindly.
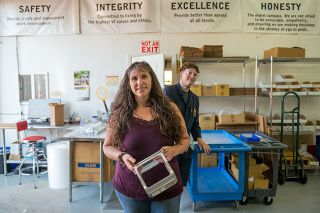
[72,141,114,182]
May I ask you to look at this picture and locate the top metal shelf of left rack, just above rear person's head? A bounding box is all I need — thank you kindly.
[181,56,250,63]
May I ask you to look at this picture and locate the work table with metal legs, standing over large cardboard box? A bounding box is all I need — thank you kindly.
[63,130,105,203]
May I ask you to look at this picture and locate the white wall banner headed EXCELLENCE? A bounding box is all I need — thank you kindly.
[161,0,241,32]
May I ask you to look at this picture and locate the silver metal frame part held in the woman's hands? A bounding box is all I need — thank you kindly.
[133,151,177,198]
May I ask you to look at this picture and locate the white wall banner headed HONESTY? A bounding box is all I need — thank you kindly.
[242,0,320,34]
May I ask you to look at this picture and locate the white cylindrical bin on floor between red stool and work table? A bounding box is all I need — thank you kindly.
[47,141,70,189]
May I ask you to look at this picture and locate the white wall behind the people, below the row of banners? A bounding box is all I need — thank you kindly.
[0,33,320,119]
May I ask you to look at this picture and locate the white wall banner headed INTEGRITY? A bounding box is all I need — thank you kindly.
[80,0,160,33]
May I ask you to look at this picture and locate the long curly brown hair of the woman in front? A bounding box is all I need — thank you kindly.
[109,62,182,148]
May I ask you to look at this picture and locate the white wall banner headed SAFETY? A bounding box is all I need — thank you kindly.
[0,0,79,36]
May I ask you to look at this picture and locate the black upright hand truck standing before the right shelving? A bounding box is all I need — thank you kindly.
[280,92,307,184]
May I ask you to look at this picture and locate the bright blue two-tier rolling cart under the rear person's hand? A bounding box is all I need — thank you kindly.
[187,130,251,211]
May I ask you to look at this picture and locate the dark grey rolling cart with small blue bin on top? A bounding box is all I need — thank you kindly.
[233,131,287,205]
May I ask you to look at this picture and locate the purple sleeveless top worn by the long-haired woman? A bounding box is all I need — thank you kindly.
[113,117,183,201]
